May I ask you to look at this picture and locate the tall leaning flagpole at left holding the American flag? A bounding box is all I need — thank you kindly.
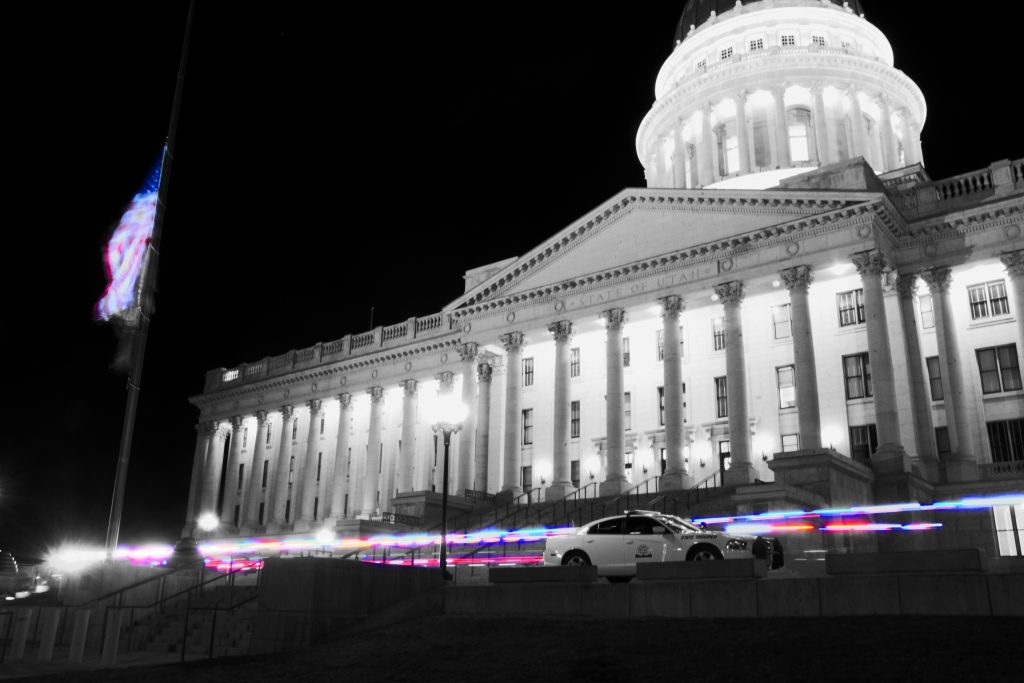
[106,0,196,557]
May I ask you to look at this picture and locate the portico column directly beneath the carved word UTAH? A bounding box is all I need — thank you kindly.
[659,296,693,490]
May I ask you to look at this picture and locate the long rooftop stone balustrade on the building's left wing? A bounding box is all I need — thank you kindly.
[204,313,453,392]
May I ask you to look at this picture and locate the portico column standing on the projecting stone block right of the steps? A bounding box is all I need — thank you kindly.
[779,265,821,451]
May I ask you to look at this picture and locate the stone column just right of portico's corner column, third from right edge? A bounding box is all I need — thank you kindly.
[896,272,939,483]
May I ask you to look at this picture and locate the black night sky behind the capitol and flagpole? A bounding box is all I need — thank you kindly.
[0,0,1024,560]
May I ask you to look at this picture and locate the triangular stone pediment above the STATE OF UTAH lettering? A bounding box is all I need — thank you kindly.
[449,184,880,310]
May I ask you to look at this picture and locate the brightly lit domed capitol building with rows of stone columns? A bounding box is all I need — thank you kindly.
[184,0,1024,554]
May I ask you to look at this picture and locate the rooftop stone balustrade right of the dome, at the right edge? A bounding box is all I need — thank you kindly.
[890,160,1024,218]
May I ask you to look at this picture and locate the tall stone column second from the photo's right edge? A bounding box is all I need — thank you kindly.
[921,266,978,482]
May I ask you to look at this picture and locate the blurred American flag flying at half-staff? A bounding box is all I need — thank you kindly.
[95,159,162,323]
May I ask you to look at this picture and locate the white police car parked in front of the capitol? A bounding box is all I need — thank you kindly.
[544,510,784,580]
